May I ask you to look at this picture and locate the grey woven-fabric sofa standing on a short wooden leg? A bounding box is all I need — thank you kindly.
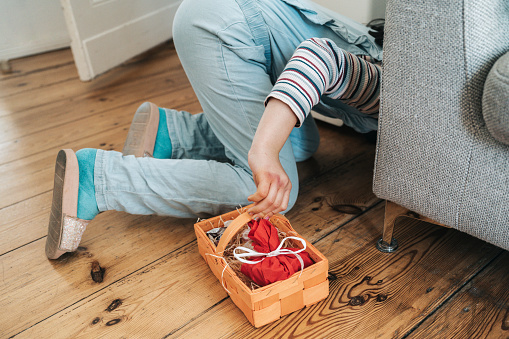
[373,0,509,250]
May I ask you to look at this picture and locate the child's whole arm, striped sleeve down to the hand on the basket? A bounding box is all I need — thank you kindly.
[248,38,381,217]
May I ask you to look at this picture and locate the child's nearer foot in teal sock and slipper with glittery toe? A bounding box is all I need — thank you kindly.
[46,149,99,259]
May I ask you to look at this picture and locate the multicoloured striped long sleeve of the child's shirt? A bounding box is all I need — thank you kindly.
[265,38,381,127]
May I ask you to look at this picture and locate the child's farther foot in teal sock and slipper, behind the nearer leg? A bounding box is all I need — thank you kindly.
[122,102,172,159]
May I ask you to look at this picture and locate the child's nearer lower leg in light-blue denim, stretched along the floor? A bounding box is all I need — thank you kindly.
[95,150,256,217]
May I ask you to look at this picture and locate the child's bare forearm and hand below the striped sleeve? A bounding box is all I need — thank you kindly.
[248,98,297,217]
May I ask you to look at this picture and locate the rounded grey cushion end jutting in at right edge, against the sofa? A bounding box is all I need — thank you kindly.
[482,52,509,145]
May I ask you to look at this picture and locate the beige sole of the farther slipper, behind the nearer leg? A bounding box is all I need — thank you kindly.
[122,102,159,157]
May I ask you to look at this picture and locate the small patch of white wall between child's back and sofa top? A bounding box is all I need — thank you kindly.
[313,0,387,24]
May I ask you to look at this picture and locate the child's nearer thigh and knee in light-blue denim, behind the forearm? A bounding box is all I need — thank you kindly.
[174,0,298,207]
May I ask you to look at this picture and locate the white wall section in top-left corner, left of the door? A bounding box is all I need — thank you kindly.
[0,0,71,60]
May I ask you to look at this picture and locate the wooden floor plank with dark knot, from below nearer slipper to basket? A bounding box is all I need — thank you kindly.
[0,212,194,336]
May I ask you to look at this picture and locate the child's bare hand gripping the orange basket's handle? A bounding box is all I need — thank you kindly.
[247,152,292,218]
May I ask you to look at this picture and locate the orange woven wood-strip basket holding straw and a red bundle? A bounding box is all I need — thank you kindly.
[194,207,329,327]
